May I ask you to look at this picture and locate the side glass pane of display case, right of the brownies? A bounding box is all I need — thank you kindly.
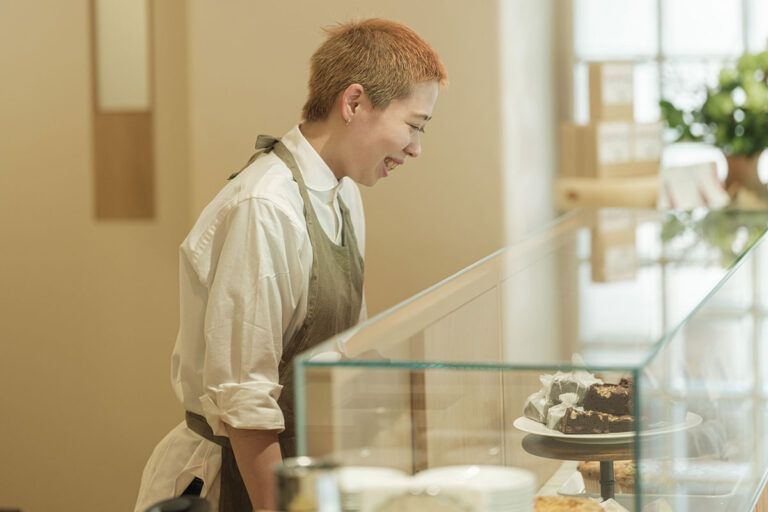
[638,296,768,510]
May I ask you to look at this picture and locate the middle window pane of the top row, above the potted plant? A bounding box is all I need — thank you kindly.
[661,0,744,56]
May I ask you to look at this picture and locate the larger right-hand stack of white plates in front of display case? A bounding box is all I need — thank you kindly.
[414,466,536,512]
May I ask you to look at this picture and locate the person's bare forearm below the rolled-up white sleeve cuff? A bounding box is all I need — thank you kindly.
[224,423,282,510]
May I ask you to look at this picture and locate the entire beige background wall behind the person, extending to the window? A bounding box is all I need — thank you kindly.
[0,0,556,512]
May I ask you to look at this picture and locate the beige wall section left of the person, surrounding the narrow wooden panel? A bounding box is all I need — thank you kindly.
[0,0,189,512]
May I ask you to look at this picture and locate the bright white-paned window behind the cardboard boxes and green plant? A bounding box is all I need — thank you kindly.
[572,0,768,181]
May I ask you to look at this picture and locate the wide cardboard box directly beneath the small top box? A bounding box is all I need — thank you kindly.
[560,121,663,178]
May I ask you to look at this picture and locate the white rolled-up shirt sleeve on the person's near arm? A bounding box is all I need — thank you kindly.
[200,199,308,435]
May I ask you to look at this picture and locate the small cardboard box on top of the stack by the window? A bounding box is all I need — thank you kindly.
[588,61,635,121]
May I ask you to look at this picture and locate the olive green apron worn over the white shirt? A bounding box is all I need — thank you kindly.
[186,135,363,512]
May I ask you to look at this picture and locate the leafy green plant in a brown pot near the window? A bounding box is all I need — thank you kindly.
[660,50,768,199]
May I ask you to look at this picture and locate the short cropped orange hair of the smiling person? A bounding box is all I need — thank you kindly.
[303,18,448,122]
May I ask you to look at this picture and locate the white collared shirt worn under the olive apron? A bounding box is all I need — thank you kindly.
[135,126,365,512]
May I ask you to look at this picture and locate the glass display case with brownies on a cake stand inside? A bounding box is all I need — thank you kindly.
[295,209,768,511]
